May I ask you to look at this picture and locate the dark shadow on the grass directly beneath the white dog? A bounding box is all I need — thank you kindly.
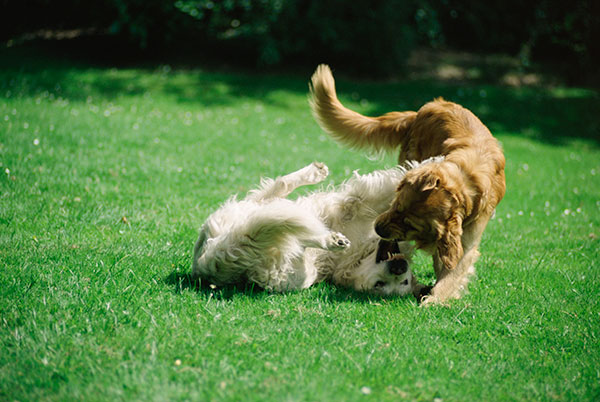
[164,271,416,304]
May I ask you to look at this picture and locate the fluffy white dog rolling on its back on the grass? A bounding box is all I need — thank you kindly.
[192,161,440,296]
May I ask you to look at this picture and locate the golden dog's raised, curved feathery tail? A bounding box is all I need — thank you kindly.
[309,64,417,151]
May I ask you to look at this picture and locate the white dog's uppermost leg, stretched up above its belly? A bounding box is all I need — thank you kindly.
[246,162,329,201]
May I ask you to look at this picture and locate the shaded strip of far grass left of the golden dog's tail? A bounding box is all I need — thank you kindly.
[0,43,310,107]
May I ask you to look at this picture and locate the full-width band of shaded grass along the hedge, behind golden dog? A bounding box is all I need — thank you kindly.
[0,43,600,147]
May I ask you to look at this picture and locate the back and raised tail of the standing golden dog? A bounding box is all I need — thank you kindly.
[310,65,505,206]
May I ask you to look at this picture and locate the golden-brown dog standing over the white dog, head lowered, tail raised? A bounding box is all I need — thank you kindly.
[310,65,506,303]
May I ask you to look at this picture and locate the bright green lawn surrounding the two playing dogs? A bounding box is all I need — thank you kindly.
[0,45,600,401]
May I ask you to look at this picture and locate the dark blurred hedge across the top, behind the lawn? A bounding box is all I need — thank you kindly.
[0,0,600,76]
